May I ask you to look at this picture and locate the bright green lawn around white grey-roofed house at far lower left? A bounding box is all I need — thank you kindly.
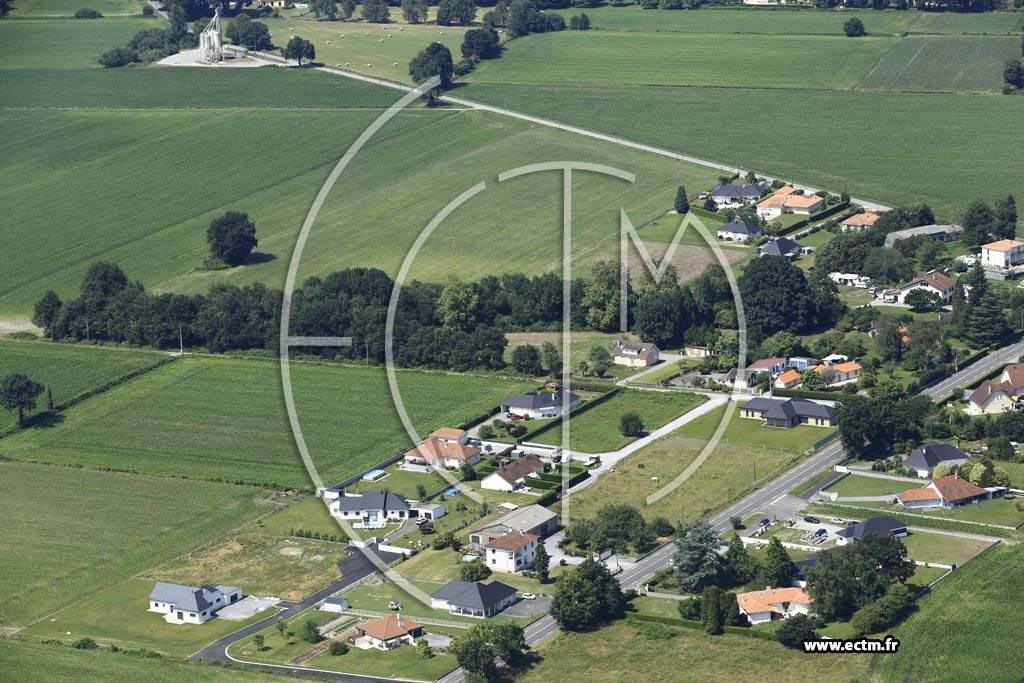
[23,579,272,658]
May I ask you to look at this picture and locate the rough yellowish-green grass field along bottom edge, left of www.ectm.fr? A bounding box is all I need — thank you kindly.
[518,622,866,683]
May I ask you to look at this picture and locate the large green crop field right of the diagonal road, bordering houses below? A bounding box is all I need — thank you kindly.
[465,79,1024,220]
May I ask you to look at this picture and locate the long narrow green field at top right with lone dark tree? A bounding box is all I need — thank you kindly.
[559,5,1024,36]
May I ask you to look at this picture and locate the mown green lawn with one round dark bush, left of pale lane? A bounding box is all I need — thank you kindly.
[532,389,707,454]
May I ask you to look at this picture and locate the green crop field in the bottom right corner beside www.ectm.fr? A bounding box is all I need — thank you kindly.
[861,545,1024,683]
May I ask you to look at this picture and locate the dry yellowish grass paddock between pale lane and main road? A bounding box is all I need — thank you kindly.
[568,430,800,521]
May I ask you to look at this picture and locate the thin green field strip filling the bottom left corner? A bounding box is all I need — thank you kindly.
[0,638,295,683]
